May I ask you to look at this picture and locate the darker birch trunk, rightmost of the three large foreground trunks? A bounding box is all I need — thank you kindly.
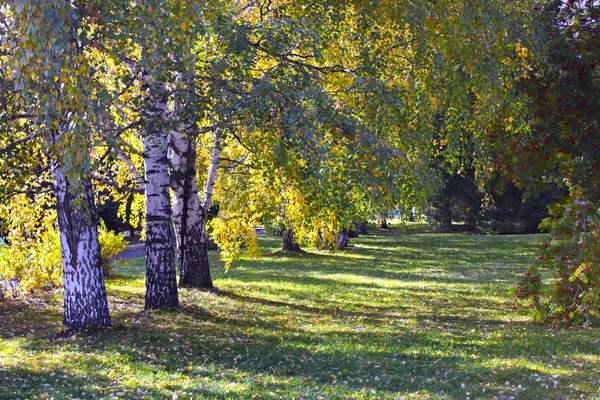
[169,124,213,289]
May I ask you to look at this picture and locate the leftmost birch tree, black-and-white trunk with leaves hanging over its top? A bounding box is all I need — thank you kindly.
[0,1,111,331]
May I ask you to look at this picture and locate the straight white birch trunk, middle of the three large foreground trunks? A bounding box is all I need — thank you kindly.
[142,76,179,309]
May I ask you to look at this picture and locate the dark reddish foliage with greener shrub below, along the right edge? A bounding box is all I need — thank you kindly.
[506,1,600,325]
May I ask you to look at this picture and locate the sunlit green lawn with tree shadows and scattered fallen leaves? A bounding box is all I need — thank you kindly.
[0,229,600,399]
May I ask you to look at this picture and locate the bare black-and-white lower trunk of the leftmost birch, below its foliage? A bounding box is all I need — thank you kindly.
[52,161,111,332]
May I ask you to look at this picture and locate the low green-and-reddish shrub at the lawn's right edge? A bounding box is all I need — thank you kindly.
[516,198,600,326]
